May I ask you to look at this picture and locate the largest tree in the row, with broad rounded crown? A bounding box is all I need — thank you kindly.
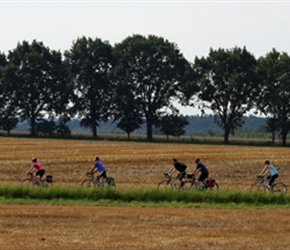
[114,35,190,141]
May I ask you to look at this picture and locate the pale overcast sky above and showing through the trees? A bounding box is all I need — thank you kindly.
[0,0,290,115]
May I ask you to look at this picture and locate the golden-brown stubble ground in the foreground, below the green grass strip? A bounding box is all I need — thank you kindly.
[0,205,290,250]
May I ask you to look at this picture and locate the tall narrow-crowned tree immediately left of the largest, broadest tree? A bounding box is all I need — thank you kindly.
[65,37,113,138]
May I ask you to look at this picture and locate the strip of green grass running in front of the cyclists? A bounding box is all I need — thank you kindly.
[0,185,290,208]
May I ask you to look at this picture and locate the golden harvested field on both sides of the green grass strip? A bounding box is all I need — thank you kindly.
[0,138,290,249]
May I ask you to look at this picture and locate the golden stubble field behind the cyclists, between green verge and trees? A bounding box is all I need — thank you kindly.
[0,138,290,189]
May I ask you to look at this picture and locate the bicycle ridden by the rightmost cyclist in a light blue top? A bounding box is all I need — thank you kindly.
[251,175,287,194]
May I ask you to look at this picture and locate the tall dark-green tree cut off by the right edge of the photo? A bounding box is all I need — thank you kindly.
[257,49,290,146]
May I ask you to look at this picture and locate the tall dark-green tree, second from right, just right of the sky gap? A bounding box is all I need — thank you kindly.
[193,47,258,143]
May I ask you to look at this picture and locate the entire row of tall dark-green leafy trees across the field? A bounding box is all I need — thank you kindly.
[0,35,290,146]
